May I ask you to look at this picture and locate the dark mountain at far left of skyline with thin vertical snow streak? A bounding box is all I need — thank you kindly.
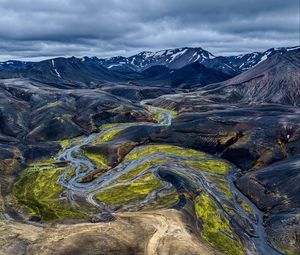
[0,57,132,87]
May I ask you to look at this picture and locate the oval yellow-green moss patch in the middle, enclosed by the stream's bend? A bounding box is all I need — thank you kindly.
[96,173,163,205]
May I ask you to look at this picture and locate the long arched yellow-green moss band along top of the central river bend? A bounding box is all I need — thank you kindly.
[125,144,207,160]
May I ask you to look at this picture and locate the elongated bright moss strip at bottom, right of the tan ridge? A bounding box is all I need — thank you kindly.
[195,193,244,255]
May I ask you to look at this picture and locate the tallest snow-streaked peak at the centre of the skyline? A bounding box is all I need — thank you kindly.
[100,47,215,71]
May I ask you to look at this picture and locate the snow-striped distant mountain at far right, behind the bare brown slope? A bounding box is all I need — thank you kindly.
[227,46,300,72]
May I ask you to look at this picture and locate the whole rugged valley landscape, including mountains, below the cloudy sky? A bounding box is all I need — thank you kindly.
[0,47,300,255]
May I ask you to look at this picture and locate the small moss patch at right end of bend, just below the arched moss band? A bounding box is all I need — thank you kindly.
[185,159,230,175]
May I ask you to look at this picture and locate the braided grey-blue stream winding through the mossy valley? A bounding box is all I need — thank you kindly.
[57,100,282,255]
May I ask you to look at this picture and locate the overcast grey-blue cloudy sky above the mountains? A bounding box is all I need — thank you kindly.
[0,0,300,61]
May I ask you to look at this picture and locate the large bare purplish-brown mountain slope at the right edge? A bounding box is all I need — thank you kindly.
[205,50,300,106]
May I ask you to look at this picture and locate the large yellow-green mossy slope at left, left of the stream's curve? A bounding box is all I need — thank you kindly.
[13,165,86,221]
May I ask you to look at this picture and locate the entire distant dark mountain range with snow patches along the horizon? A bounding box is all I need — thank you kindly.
[0,46,299,89]
